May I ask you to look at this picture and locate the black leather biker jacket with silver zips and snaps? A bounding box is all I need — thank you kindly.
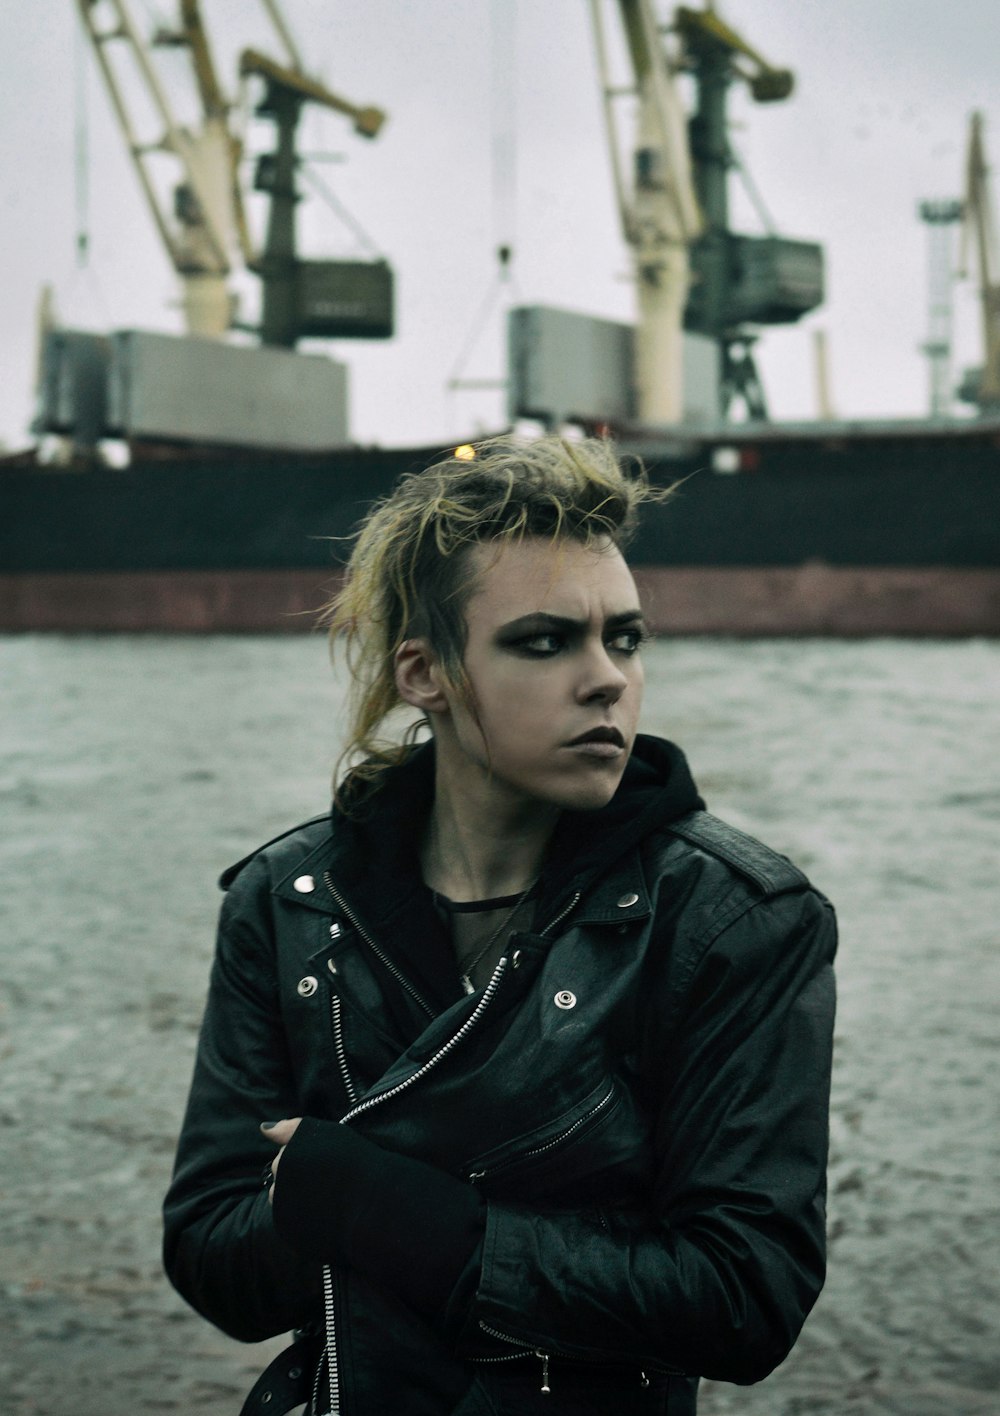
[164,739,836,1416]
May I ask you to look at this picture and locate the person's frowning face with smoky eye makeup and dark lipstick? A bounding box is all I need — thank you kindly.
[438,537,644,810]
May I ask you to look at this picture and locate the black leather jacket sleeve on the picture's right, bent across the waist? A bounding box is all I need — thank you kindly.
[466,889,836,1382]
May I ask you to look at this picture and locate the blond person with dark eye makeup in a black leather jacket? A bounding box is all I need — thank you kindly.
[166,438,834,1416]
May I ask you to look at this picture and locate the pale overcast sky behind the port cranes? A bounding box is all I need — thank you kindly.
[0,0,1000,446]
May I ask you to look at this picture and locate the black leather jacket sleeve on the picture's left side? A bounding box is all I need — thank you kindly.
[163,860,322,1342]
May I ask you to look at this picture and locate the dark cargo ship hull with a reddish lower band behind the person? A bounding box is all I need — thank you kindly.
[0,422,1000,636]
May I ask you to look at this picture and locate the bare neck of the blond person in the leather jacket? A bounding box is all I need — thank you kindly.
[421,777,559,902]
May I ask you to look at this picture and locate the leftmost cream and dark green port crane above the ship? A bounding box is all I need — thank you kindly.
[76,0,392,348]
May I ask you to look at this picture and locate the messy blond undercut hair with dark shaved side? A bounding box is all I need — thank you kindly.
[322,436,667,800]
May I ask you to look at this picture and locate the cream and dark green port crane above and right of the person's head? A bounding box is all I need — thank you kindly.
[591,0,823,423]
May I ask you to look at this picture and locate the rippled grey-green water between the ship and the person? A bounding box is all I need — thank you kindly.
[0,636,1000,1416]
